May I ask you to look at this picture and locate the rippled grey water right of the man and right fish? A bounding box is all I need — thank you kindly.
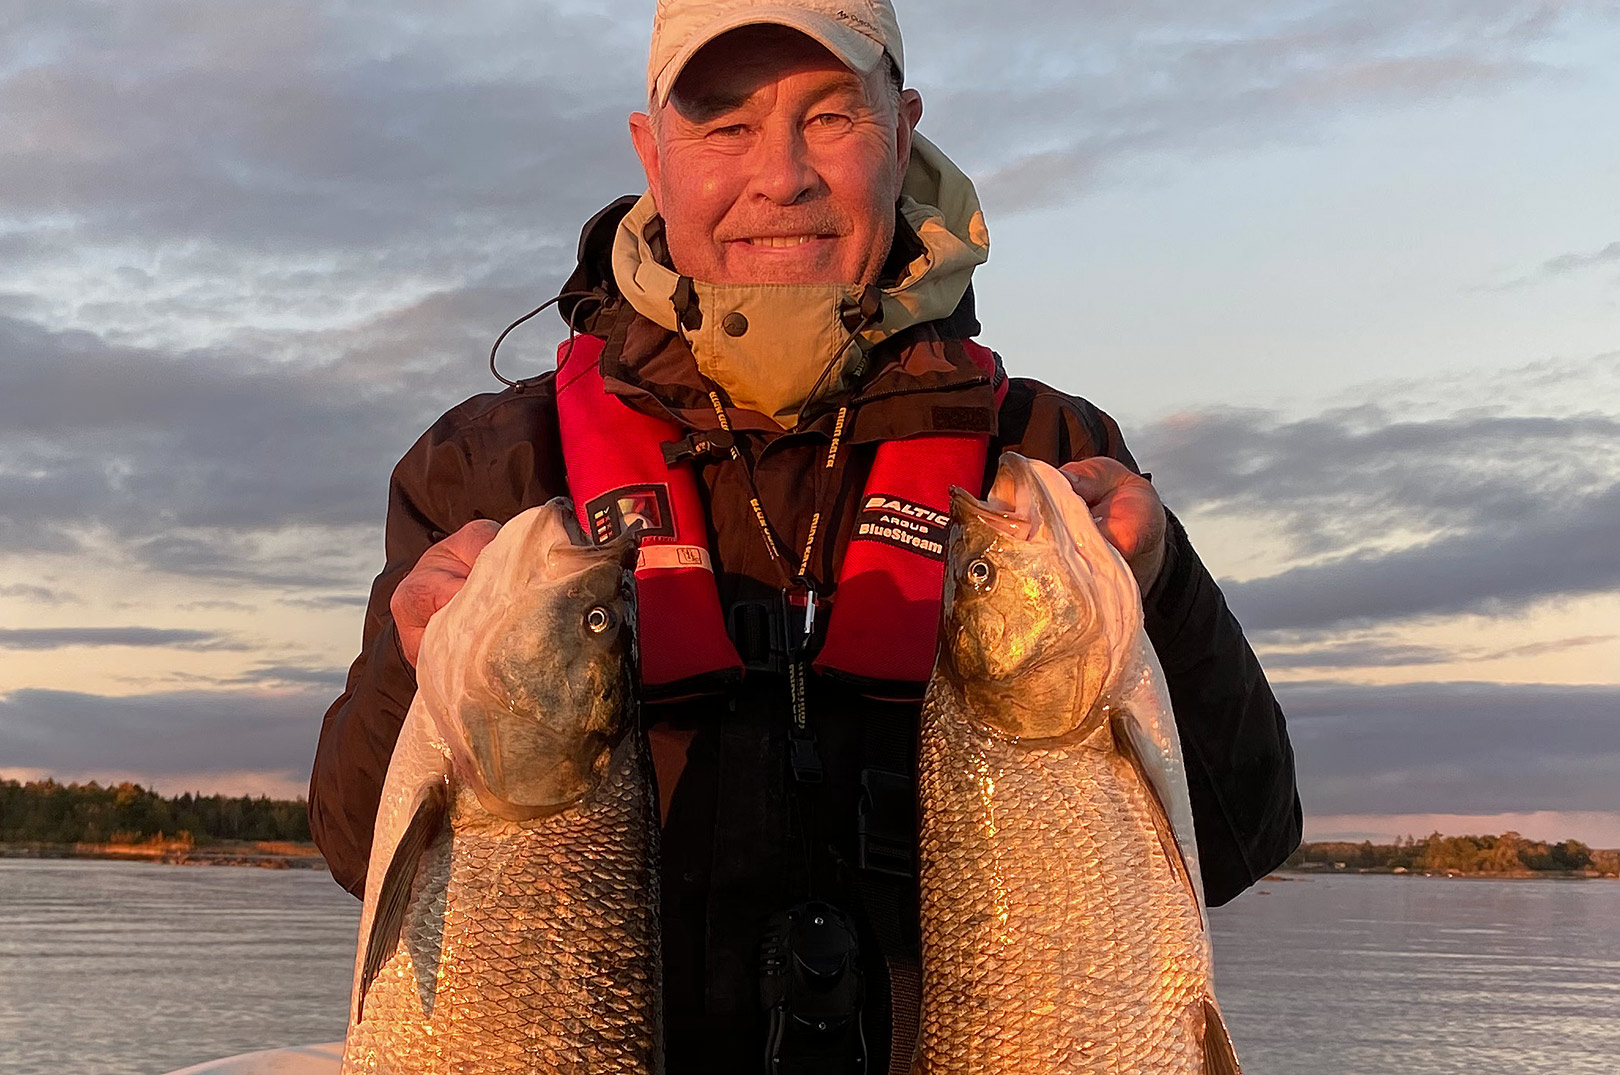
[1210,874,1620,1075]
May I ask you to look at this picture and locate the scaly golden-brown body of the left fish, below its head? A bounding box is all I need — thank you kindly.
[343,735,659,1075]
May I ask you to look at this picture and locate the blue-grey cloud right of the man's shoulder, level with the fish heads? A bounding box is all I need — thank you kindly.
[1137,396,1620,631]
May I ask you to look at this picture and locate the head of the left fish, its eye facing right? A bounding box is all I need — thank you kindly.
[423,500,637,821]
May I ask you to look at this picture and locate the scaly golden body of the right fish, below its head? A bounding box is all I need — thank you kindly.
[919,702,1209,1073]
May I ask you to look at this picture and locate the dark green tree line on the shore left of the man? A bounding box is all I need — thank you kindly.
[0,780,309,843]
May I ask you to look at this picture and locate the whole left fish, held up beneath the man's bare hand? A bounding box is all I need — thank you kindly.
[342,499,663,1075]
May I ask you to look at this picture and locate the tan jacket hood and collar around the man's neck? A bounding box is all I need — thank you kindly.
[611,136,990,429]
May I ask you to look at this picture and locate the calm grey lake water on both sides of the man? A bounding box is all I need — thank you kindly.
[0,860,1620,1075]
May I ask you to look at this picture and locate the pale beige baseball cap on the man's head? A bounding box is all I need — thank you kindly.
[646,0,906,108]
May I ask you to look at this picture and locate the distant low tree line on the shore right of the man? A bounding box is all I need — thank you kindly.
[1283,832,1620,874]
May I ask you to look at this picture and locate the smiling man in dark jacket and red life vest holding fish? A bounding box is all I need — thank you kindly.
[309,0,1299,1072]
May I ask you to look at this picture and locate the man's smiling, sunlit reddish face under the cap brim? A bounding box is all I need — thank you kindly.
[630,26,922,285]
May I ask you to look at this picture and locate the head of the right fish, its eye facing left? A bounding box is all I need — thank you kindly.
[940,452,1140,740]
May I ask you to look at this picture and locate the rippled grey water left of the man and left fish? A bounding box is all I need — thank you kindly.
[0,860,360,1075]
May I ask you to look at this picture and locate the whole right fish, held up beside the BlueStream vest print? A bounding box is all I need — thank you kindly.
[912,452,1239,1075]
